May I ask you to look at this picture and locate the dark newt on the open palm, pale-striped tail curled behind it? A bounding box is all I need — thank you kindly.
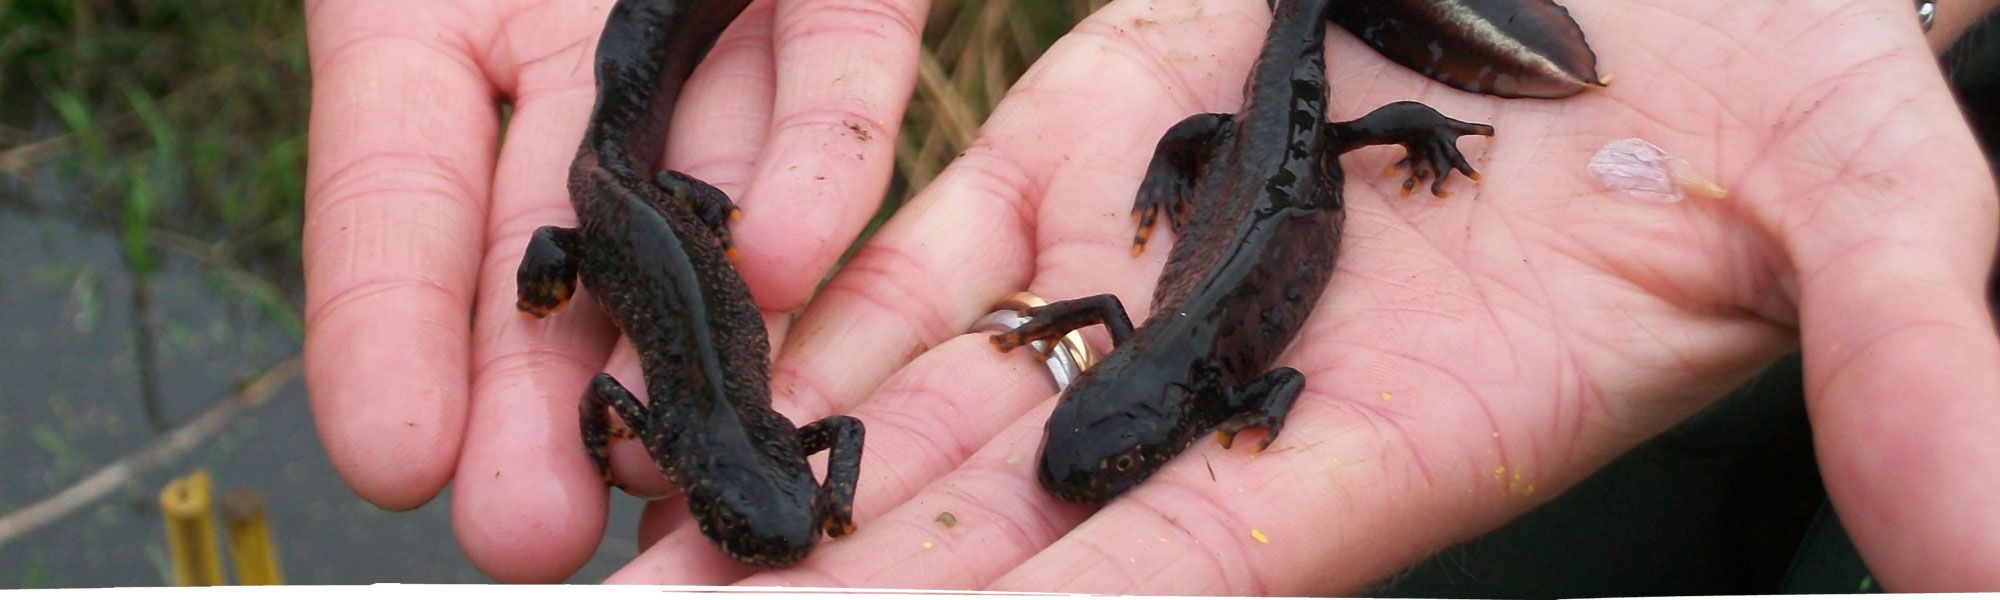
[992,0,1598,502]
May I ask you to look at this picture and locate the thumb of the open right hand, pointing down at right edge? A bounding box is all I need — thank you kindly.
[1788,76,2000,592]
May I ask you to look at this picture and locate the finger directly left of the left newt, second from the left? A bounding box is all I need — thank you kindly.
[452,4,616,582]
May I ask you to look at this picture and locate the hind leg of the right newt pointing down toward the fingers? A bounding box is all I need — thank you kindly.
[1132,114,1232,256]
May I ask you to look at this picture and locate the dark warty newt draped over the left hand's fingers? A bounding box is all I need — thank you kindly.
[516,0,862,566]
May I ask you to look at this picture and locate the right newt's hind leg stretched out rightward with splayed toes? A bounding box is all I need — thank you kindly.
[1328,102,1494,198]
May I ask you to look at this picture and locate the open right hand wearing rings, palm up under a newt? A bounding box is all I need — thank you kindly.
[612,0,2000,594]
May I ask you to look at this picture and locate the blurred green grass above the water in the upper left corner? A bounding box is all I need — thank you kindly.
[0,0,308,288]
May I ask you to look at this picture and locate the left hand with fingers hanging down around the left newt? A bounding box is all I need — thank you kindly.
[304,0,926,582]
